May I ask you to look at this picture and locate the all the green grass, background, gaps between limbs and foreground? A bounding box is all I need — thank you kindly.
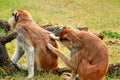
[0,0,120,80]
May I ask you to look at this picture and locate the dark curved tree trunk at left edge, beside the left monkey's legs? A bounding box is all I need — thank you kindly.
[0,33,19,74]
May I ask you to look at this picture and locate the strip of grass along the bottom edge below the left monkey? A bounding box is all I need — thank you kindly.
[0,71,64,80]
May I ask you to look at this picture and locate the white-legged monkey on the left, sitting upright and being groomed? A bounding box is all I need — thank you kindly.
[8,10,59,78]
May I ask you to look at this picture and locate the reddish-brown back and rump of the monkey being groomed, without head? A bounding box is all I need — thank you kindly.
[15,22,58,71]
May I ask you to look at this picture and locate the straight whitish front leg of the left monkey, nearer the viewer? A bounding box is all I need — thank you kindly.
[26,46,34,78]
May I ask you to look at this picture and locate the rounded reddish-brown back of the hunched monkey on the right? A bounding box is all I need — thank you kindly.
[79,31,109,80]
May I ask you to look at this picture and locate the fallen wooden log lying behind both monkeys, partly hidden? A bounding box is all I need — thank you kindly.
[0,20,104,40]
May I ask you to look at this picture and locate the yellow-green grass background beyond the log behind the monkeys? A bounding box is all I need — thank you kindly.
[0,0,120,32]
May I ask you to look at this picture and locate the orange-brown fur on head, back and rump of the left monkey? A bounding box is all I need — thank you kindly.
[9,10,58,71]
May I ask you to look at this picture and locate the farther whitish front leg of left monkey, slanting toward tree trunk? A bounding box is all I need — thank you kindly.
[12,42,24,63]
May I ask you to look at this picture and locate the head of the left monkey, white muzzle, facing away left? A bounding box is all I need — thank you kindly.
[8,10,32,29]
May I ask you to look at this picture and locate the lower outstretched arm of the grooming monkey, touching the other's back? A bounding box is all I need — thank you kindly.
[47,43,74,69]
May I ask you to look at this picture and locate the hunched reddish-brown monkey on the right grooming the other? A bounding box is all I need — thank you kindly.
[47,28,109,80]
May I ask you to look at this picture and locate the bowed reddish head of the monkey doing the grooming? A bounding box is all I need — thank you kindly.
[59,28,81,49]
